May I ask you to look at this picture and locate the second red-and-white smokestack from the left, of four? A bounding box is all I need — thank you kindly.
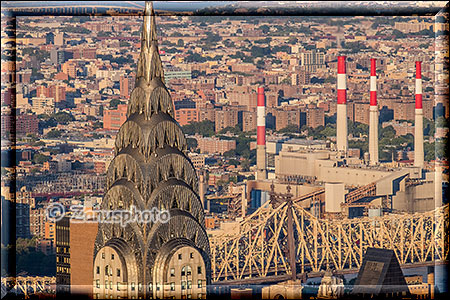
[336,56,348,156]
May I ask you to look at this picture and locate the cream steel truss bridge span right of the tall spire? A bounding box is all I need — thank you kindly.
[210,201,449,282]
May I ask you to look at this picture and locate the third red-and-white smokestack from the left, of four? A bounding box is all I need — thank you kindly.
[369,58,378,165]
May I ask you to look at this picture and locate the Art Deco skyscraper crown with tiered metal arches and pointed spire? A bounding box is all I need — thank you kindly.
[93,2,211,299]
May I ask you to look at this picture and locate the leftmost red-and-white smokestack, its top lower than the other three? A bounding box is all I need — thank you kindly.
[256,87,267,180]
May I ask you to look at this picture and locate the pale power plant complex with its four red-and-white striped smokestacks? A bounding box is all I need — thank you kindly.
[246,56,442,218]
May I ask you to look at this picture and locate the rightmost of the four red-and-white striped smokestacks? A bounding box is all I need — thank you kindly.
[414,61,424,167]
